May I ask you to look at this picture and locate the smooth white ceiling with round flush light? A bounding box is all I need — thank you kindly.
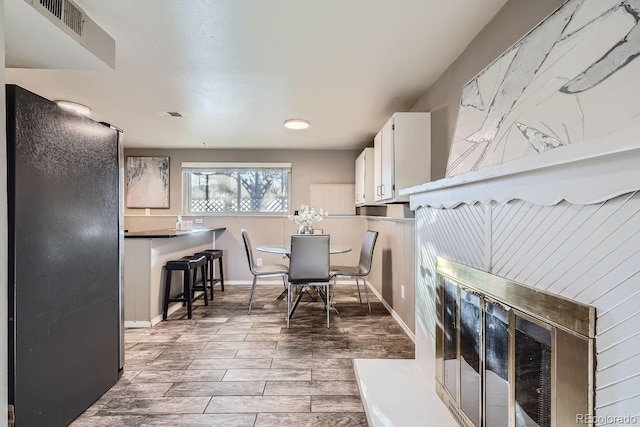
[5,0,506,149]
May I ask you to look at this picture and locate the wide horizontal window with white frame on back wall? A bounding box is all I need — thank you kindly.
[182,162,291,215]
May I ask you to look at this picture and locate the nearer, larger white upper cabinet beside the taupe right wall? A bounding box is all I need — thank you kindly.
[373,113,431,203]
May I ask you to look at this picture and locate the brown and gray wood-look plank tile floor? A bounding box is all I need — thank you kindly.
[71,285,414,427]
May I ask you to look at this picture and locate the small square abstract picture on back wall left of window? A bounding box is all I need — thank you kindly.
[126,156,169,209]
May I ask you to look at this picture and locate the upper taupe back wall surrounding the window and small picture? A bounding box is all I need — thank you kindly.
[124,150,360,217]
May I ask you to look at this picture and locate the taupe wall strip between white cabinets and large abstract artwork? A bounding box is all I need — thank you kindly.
[411,0,565,181]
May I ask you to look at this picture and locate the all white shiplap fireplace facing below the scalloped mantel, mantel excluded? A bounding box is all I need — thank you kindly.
[416,193,640,415]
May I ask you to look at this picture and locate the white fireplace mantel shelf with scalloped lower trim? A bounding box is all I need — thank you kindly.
[400,129,640,210]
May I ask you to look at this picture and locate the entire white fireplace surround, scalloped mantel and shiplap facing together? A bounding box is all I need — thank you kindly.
[404,139,640,422]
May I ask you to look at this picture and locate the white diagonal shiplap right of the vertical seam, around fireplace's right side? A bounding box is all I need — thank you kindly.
[491,194,640,415]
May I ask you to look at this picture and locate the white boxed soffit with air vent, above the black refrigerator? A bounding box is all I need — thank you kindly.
[4,0,116,70]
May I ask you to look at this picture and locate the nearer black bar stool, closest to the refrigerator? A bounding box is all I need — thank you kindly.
[162,256,209,320]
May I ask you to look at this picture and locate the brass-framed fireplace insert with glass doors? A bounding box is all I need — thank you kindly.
[436,258,595,427]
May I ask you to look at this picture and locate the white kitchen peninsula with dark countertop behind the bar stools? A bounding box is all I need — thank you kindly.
[124,228,226,328]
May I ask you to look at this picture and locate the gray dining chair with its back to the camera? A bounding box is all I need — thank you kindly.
[287,234,331,328]
